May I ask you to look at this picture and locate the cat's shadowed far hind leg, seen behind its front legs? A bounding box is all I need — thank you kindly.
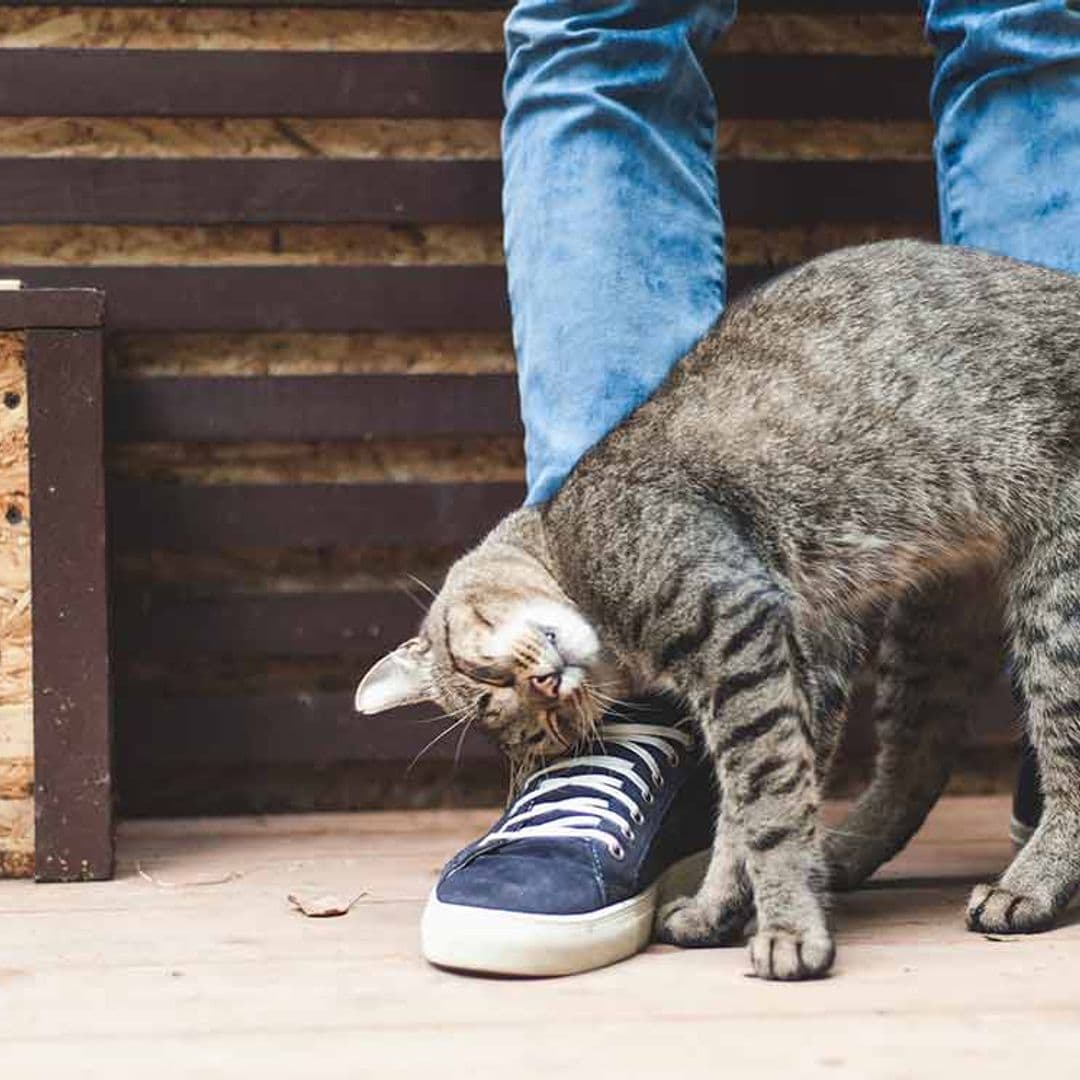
[825,567,1002,889]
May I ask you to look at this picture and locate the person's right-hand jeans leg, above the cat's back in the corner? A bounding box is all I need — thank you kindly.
[927,0,1080,273]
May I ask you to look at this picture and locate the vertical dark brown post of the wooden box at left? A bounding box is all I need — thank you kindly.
[27,326,112,881]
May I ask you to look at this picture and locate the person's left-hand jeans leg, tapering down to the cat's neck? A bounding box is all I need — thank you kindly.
[503,0,734,502]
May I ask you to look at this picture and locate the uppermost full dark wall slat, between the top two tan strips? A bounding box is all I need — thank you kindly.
[0,49,930,119]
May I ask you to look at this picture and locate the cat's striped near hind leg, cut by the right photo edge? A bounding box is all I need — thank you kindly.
[967,481,1080,934]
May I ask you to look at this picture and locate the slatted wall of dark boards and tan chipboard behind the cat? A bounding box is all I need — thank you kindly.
[0,0,963,813]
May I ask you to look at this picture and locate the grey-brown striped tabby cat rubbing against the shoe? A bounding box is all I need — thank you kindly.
[357,241,1080,980]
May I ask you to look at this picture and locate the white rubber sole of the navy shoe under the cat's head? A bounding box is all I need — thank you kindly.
[420,850,710,975]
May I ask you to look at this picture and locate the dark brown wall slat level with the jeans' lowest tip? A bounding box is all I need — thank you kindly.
[109,480,525,550]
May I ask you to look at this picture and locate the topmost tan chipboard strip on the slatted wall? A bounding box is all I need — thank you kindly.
[0,6,929,56]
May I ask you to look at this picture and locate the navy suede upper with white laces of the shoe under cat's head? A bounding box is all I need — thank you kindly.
[435,702,716,915]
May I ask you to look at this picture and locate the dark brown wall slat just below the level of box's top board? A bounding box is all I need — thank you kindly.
[106,375,521,443]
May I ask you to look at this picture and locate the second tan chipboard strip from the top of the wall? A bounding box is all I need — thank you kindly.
[0,117,933,161]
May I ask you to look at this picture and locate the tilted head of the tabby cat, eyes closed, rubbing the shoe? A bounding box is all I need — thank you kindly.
[356,520,619,761]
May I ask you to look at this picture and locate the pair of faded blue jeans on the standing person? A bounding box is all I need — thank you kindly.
[503,0,1080,502]
